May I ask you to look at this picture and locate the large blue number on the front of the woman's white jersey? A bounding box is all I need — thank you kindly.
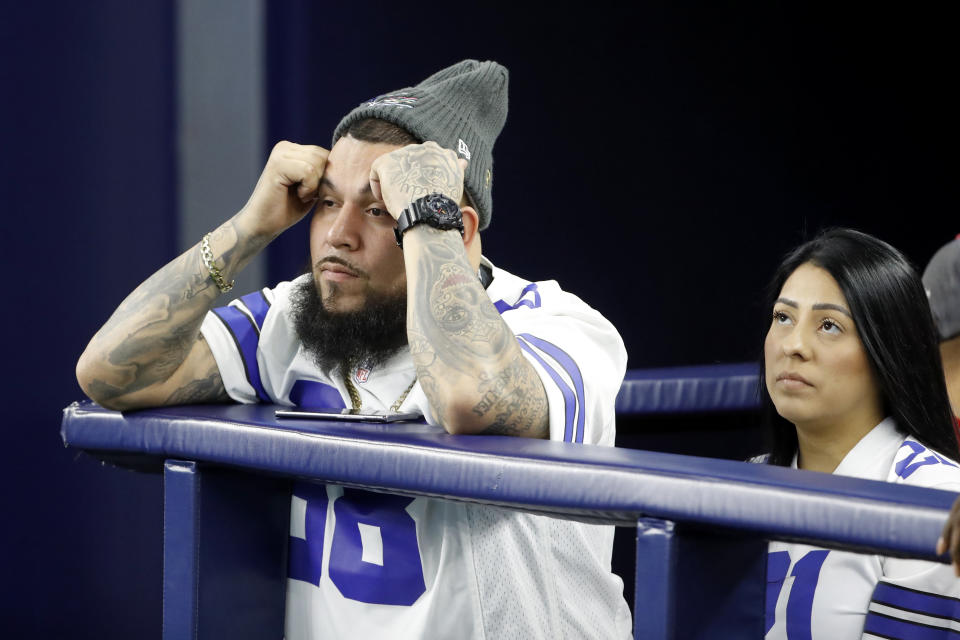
[764,549,830,640]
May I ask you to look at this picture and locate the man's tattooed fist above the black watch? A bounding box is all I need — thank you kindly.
[370,142,467,219]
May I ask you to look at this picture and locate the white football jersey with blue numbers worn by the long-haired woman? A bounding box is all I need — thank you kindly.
[766,418,960,640]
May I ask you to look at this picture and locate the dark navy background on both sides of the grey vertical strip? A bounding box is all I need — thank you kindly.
[0,0,960,638]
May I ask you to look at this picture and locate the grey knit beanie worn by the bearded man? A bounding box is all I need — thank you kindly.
[333,60,508,229]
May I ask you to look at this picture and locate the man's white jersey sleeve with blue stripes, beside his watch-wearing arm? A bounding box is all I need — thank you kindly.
[494,282,627,446]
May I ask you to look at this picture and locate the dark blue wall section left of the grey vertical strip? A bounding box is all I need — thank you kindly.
[0,1,176,638]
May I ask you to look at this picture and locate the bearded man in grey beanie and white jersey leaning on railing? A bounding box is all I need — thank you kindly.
[77,60,630,640]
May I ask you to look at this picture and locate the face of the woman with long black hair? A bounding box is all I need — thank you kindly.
[764,262,884,431]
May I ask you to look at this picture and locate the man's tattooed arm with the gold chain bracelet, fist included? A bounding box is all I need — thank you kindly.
[77,142,327,409]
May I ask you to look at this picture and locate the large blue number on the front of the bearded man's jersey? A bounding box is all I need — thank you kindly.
[289,486,426,605]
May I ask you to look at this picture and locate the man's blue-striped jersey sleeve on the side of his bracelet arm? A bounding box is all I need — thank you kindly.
[200,289,273,404]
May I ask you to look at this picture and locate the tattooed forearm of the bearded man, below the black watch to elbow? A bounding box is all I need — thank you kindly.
[407,227,548,437]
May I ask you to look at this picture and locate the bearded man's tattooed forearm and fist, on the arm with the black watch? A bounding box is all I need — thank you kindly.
[371,142,549,438]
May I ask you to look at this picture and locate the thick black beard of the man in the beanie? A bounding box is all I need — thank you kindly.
[290,276,407,375]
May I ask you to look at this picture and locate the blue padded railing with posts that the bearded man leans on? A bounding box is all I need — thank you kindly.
[62,364,955,639]
